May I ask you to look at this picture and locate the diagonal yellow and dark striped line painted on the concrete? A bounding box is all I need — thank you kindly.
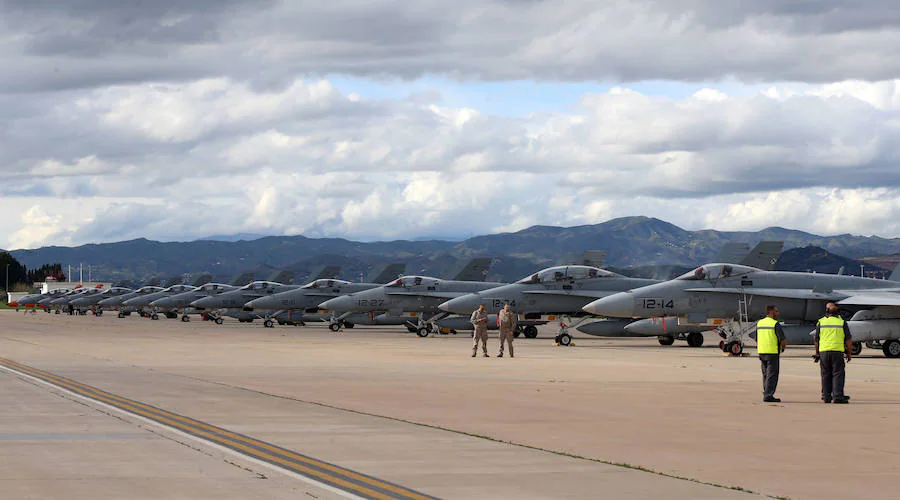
[0,358,435,500]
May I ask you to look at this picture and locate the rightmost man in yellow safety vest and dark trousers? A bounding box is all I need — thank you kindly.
[816,302,853,404]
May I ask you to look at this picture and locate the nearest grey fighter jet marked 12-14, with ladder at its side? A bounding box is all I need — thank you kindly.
[584,263,900,357]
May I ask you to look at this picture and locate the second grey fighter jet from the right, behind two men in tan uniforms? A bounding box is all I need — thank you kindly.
[439,266,659,345]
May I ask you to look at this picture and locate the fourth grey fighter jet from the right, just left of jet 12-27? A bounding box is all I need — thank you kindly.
[243,263,406,331]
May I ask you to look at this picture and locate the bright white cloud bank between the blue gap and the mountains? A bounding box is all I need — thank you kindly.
[0,75,900,246]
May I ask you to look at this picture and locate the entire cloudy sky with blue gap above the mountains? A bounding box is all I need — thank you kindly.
[0,0,900,248]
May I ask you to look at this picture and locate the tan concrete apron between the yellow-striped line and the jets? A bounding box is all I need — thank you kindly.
[0,311,900,498]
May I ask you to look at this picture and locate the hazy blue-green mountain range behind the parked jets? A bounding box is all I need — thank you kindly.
[11,217,900,281]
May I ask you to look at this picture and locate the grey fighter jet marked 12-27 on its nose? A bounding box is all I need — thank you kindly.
[319,270,502,337]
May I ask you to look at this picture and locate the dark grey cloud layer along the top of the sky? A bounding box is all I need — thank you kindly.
[0,0,900,92]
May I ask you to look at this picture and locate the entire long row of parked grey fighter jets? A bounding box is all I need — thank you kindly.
[12,241,900,357]
